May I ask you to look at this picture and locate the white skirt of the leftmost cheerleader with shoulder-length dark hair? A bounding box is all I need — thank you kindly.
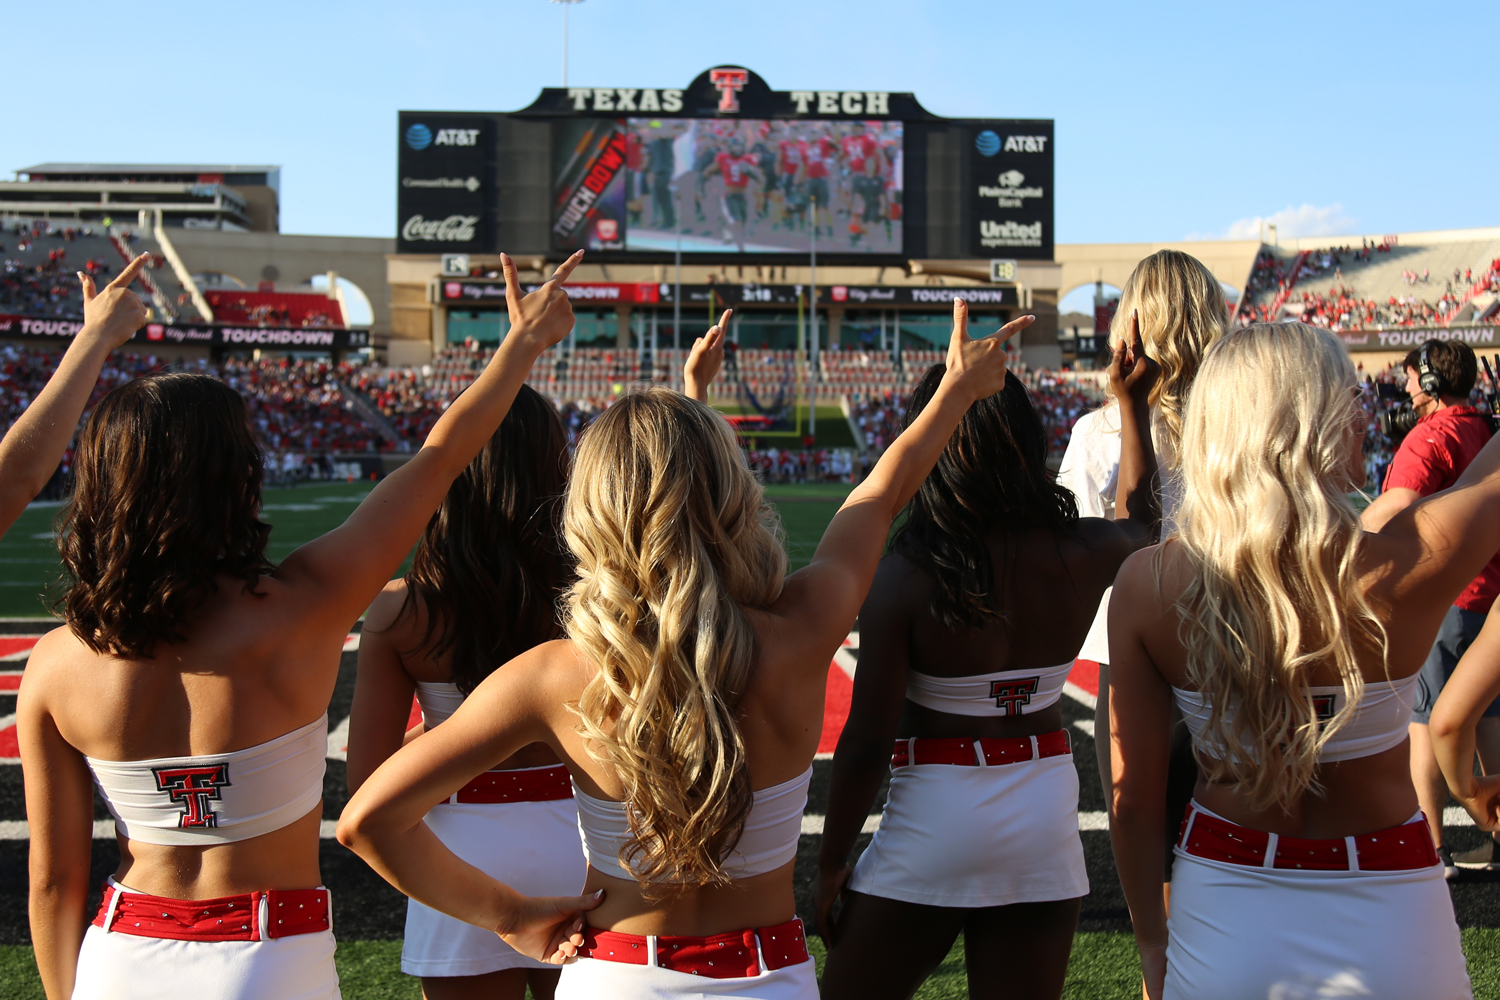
[72,924,339,1000]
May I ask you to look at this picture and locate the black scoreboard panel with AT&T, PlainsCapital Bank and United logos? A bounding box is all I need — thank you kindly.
[965,120,1053,262]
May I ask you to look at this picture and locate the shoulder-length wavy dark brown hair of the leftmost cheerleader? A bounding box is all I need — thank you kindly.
[54,373,275,658]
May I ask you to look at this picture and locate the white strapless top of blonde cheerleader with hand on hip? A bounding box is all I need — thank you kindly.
[573,766,813,882]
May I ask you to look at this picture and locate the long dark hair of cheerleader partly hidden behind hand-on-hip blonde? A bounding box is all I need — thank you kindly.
[401,385,572,694]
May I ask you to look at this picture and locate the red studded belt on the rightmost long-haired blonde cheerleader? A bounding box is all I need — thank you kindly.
[1178,802,1437,871]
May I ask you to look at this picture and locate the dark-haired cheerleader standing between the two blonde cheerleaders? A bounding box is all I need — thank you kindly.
[816,327,1157,1000]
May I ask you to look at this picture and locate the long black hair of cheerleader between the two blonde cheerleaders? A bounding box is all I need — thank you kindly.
[891,364,1079,628]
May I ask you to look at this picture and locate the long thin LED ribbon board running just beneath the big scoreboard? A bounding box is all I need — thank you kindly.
[440,280,1019,310]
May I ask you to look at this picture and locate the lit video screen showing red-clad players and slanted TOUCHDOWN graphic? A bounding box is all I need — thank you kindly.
[552,118,903,253]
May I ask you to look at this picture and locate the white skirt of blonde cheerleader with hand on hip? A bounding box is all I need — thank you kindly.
[557,958,818,1000]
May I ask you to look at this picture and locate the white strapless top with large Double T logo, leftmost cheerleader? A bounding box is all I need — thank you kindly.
[86,715,329,847]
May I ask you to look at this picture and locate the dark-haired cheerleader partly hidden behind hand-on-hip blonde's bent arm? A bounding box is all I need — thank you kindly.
[348,385,585,1000]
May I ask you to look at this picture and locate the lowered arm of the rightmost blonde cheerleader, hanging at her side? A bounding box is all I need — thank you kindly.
[1109,549,1172,1000]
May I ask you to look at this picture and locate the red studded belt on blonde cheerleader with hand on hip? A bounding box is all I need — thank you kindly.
[578,919,807,979]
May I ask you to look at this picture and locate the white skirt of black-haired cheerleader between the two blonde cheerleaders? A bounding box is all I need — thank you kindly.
[849,754,1089,909]
